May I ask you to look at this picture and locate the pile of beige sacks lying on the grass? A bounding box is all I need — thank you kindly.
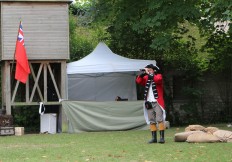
[174,125,232,143]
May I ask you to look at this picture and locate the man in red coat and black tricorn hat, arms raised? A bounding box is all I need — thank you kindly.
[136,64,166,143]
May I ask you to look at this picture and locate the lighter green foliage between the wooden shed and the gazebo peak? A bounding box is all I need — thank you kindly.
[69,1,107,61]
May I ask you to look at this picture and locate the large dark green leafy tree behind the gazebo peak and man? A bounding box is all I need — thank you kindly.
[94,0,208,122]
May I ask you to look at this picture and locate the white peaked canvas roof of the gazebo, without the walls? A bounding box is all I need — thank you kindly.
[67,42,156,74]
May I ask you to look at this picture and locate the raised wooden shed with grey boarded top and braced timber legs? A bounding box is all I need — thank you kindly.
[0,0,72,121]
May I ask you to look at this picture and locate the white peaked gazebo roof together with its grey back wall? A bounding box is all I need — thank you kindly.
[67,42,156,101]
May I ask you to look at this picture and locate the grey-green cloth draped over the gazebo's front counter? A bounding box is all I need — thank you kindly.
[62,101,147,133]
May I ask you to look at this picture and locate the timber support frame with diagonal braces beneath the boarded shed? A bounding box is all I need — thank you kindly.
[2,60,67,115]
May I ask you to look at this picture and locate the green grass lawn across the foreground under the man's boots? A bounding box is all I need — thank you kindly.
[0,124,232,162]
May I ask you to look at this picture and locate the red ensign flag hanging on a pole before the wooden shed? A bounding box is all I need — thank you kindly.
[15,21,31,84]
